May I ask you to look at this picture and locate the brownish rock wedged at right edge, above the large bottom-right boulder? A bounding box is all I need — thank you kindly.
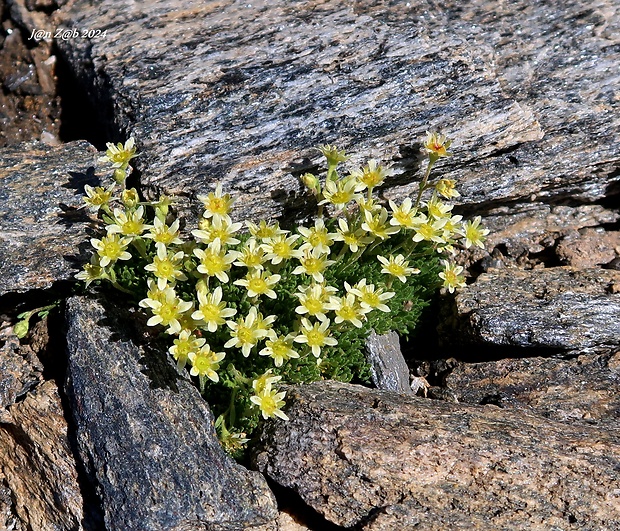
[445,351,620,429]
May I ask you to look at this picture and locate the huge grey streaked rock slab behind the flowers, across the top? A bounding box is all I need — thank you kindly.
[56,0,620,224]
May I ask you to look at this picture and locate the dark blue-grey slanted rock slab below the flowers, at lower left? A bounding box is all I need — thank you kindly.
[67,298,277,531]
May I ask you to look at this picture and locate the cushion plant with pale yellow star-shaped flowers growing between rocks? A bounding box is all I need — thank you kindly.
[77,133,488,451]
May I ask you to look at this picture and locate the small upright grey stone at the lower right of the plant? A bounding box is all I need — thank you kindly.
[366,330,415,395]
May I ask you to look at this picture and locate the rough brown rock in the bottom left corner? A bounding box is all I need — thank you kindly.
[0,382,84,531]
